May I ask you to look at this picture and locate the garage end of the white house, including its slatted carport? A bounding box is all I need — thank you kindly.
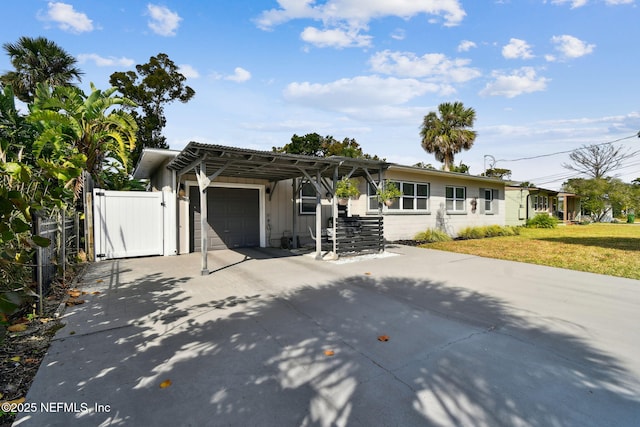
[134,141,388,275]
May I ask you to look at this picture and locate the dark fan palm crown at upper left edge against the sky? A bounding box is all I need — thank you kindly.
[0,37,83,103]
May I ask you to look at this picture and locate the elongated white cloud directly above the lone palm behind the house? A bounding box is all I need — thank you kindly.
[369,50,481,83]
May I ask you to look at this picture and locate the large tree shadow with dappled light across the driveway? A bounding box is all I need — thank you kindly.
[17,264,640,427]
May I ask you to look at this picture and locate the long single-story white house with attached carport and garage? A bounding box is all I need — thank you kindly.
[134,142,505,270]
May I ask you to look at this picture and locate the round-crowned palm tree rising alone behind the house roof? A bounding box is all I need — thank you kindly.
[420,102,476,171]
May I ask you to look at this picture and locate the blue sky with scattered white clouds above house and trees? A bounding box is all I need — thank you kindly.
[0,0,640,189]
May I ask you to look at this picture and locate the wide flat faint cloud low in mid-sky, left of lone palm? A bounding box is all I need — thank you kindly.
[284,76,440,113]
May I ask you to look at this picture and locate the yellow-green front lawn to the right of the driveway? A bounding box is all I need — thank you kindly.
[422,224,640,280]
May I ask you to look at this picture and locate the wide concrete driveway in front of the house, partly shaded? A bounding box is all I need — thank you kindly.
[14,246,640,427]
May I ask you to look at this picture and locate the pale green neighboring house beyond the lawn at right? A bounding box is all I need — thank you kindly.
[505,185,580,226]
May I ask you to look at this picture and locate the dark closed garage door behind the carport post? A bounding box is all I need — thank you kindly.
[189,186,260,252]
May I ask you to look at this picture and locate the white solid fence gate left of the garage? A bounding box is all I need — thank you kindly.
[93,188,165,261]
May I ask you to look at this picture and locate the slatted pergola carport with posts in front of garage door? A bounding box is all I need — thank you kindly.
[167,142,389,274]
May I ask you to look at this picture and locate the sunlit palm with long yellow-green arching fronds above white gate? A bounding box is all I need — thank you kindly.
[29,83,138,184]
